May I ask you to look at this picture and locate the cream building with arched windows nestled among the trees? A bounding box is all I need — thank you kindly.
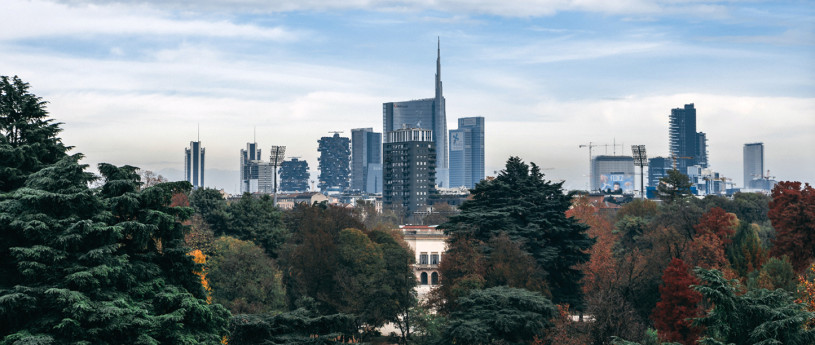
[399,225,447,298]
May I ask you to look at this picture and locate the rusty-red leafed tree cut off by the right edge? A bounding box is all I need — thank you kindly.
[767,181,815,272]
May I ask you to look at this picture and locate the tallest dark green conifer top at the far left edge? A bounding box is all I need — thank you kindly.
[0,76,70,192]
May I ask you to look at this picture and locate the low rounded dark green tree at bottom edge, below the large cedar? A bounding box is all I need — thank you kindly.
[442,286,557,344]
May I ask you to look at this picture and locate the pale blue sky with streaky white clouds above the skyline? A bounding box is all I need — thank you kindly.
[0,0,815,193]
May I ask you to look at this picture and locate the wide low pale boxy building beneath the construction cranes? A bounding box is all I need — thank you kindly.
[591,156,635,194]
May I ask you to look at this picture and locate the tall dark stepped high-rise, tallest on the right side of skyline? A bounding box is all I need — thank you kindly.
[668,103,708,174]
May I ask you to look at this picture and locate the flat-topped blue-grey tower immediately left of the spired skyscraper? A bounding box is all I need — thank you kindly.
[351,128,382,193]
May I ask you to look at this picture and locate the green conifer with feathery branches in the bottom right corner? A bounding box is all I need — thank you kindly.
[694,268,815,345]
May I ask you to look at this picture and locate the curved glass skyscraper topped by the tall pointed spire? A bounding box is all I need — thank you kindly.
[382,39,450,187]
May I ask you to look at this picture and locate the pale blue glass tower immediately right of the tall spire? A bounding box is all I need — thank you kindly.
[450,116,484,189]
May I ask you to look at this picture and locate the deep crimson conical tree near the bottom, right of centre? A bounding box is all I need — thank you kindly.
[652,258,702,345]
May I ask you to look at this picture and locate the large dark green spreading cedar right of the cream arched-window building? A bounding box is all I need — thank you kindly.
[441,157,594,306]
